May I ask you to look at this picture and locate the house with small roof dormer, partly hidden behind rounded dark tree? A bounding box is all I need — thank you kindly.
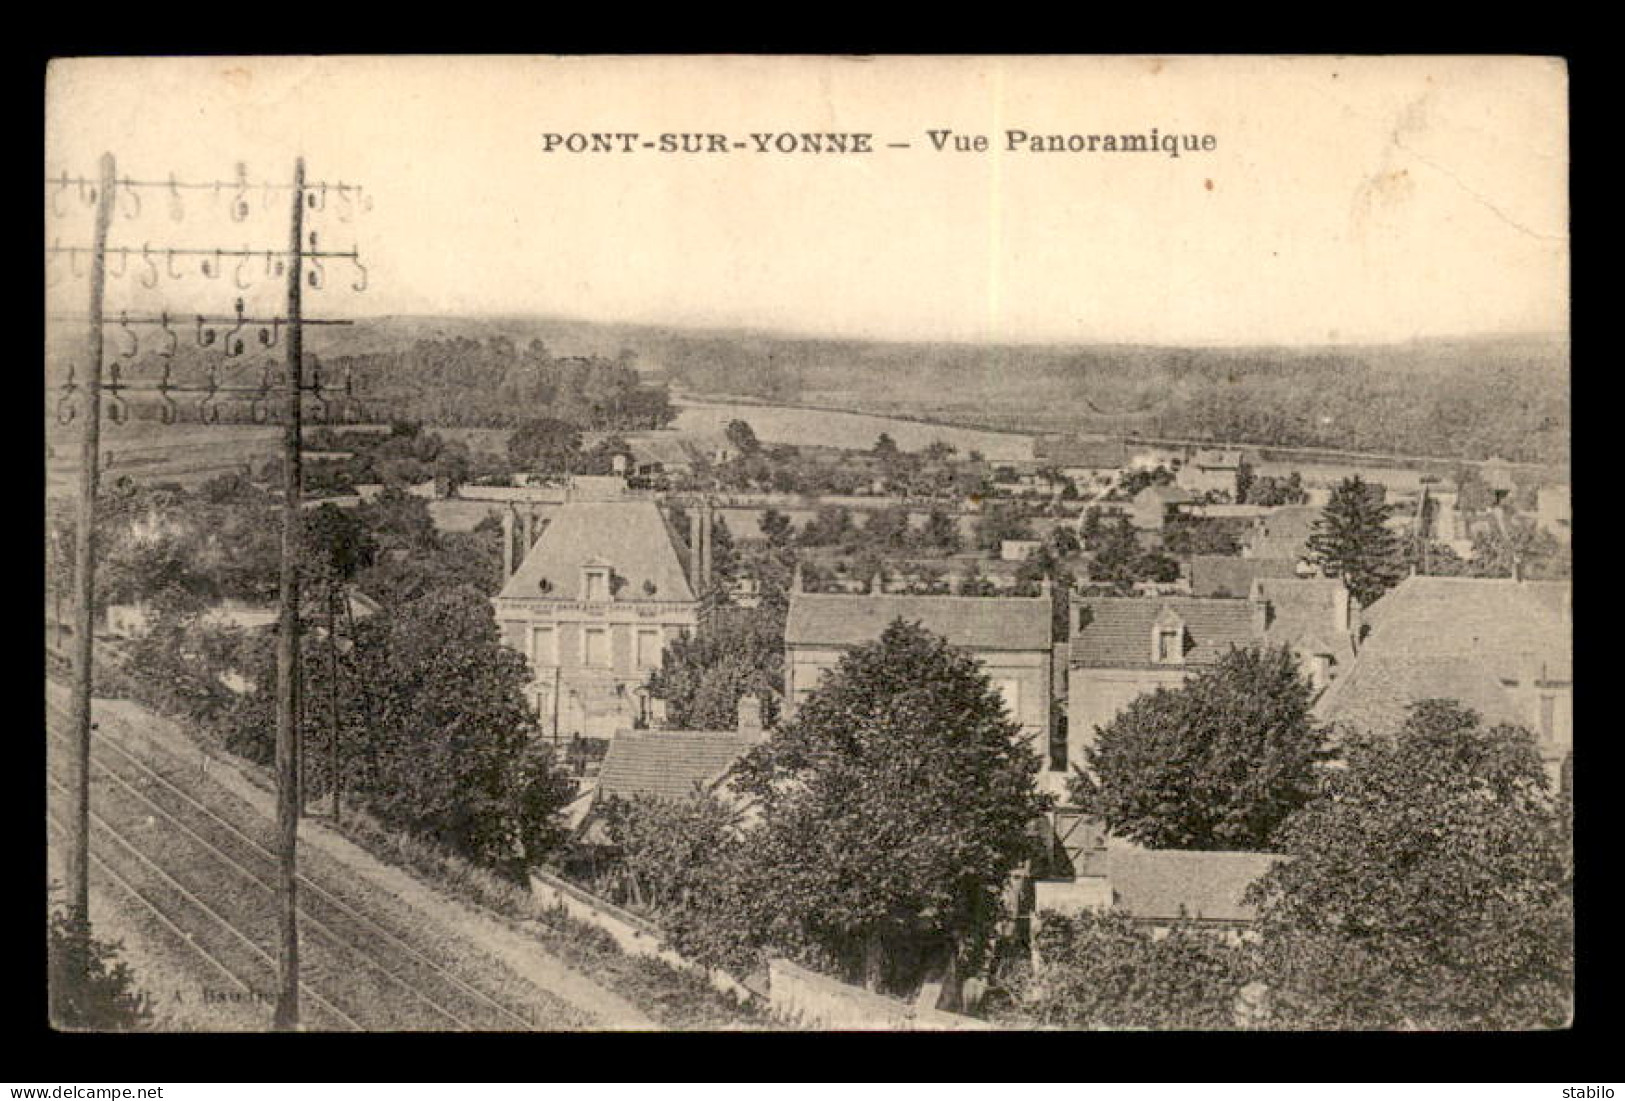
[1068,576,1360,768]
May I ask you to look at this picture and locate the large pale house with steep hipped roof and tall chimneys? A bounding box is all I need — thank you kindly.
[492,477,710,742]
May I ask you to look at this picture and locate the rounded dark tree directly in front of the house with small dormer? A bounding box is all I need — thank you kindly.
[1073,646,1323,851]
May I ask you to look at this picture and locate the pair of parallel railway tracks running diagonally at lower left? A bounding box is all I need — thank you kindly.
[47,703,565,1031]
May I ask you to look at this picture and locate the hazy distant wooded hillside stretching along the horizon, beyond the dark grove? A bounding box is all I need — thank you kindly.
[47,317,1570,463]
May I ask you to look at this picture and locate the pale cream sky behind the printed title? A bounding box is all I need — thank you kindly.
[46,57,1570,344]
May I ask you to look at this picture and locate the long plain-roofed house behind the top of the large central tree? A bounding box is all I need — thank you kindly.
[785,572,1066,783]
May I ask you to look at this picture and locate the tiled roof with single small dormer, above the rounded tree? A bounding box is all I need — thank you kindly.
[1073,596,1258,669]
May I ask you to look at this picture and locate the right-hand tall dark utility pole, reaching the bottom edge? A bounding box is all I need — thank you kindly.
[273,158,306,1031]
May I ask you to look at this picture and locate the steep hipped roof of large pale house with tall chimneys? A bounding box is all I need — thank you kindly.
[501,500,694,602]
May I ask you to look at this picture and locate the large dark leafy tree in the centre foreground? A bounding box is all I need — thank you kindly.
[739,620,1048,991]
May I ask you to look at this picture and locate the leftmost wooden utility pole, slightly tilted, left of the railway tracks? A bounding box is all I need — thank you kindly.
[70,153,117,927]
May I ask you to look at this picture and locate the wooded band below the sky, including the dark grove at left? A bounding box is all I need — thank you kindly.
[47,317,1570,463]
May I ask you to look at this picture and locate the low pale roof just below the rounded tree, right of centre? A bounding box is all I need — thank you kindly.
[1107,846,1287,921]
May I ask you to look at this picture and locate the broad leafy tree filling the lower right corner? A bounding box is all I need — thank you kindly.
[1253,700,1575,1030]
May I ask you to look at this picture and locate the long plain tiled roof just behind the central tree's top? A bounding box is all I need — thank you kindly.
[785,593,1051,650]
